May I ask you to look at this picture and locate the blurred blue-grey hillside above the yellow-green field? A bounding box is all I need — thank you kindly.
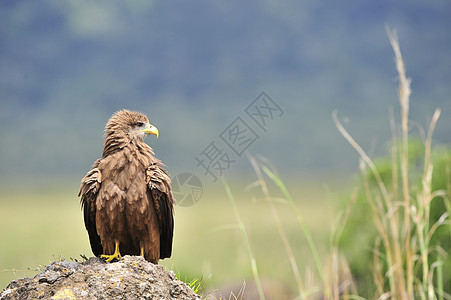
[0,0,451,183]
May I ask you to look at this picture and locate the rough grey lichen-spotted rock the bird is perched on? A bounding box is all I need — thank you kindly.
[0,255,200,300]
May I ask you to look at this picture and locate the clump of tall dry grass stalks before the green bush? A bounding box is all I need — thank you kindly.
[333,28,449,300]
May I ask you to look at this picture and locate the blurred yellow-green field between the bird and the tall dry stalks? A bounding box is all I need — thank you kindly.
[163,181,331,288]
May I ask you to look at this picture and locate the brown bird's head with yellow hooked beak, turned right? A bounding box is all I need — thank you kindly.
[105,109,158,142]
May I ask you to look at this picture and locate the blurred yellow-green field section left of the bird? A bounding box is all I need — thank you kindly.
[0,185,89,288]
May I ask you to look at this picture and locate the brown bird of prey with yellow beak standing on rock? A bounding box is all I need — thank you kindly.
[78,110,174,264]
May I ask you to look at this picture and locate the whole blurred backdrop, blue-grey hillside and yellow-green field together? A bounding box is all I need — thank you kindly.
[0,0,451,288]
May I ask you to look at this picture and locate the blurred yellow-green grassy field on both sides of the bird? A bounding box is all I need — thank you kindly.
[0,178,338,289]
